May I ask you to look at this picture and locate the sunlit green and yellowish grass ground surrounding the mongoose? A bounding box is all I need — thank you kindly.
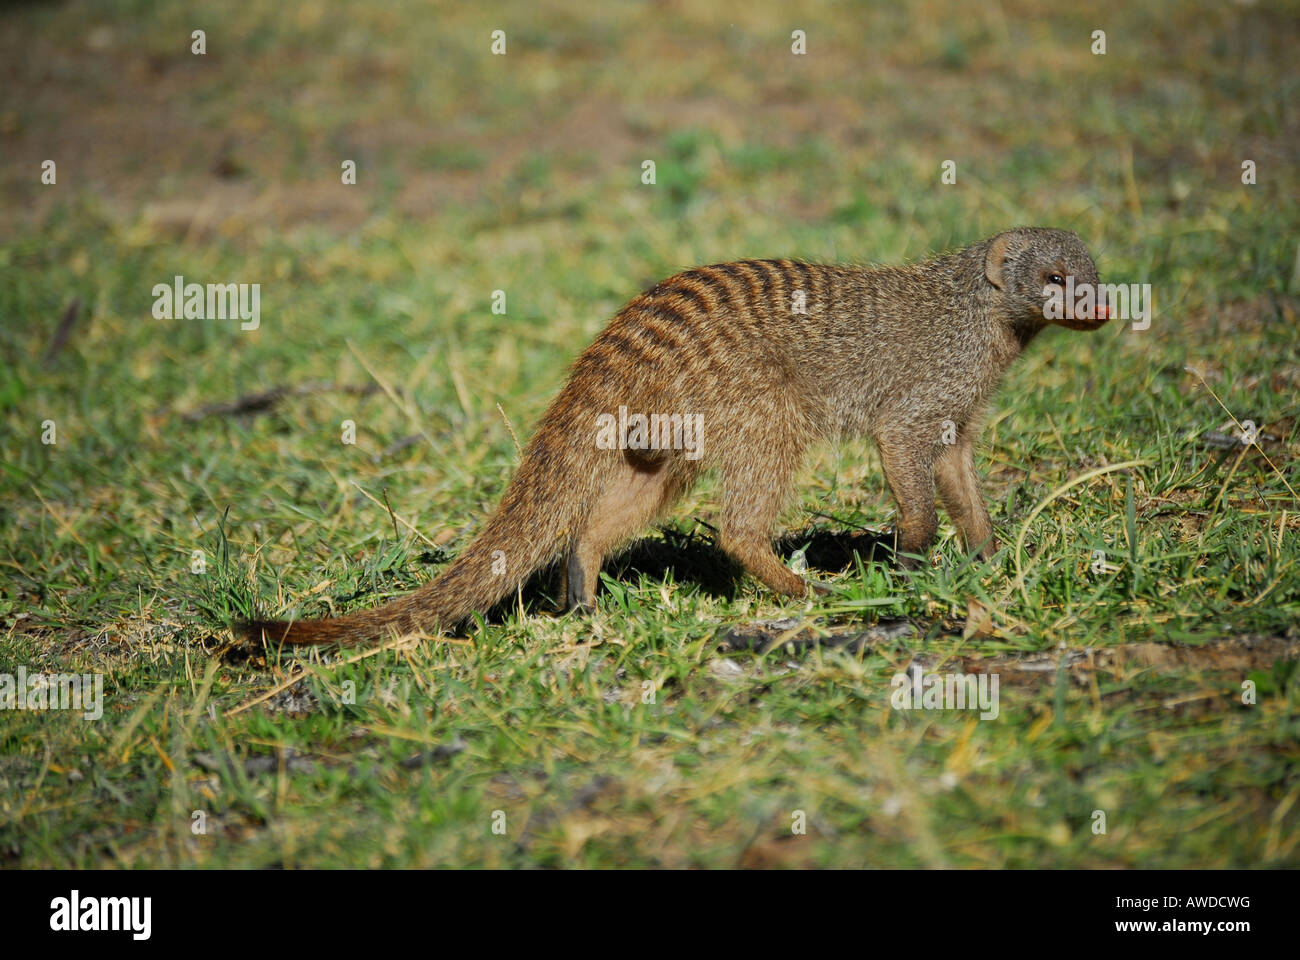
[0,0,1300,868]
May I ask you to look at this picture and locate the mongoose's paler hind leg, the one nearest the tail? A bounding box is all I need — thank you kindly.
[563,451,692,613]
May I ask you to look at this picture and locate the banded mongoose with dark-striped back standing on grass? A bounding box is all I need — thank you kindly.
[239,228,1109,644]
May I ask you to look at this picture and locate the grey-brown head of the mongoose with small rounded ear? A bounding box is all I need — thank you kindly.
[984,226,1110,330]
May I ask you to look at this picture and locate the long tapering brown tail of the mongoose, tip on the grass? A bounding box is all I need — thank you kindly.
[234,400,602,647]
